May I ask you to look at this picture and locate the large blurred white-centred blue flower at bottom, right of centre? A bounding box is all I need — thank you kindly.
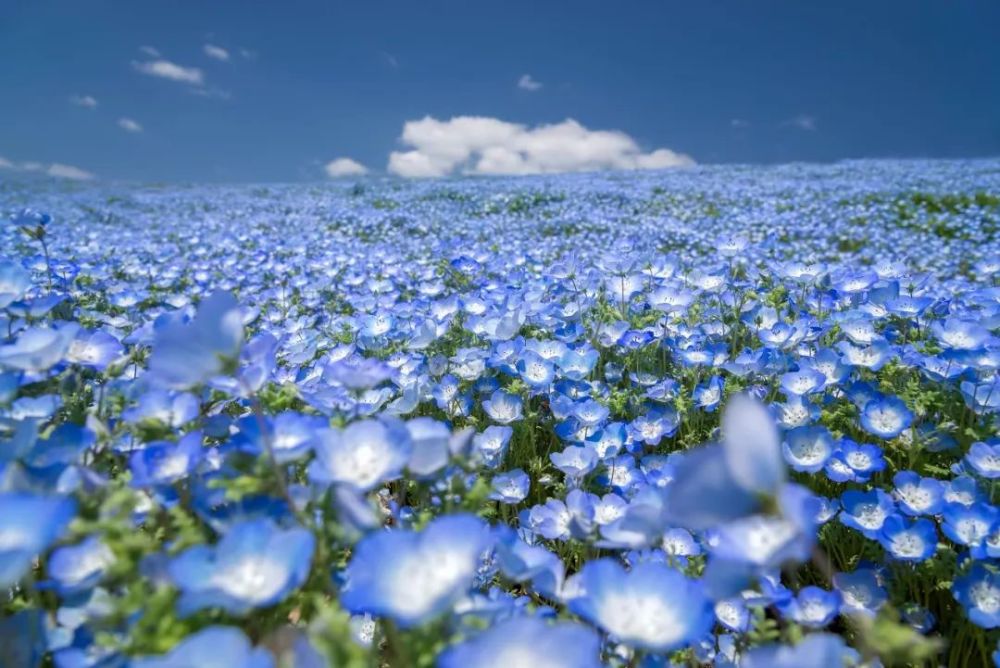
[569,559,715,652]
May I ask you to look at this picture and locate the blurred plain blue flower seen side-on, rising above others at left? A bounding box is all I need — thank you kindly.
[149,292,243,389]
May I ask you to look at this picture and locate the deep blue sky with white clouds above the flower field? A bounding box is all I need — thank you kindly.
[0,0,1000,181]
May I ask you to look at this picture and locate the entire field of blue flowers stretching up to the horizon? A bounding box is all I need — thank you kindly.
[0,161,1000,668]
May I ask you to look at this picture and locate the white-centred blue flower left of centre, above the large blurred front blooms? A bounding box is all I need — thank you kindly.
[308,417,413,491]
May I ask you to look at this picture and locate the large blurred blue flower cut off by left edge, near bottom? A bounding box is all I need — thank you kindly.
[0,492,76,587]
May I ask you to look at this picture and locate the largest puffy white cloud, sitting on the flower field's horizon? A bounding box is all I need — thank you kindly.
[388,116,694,178]
